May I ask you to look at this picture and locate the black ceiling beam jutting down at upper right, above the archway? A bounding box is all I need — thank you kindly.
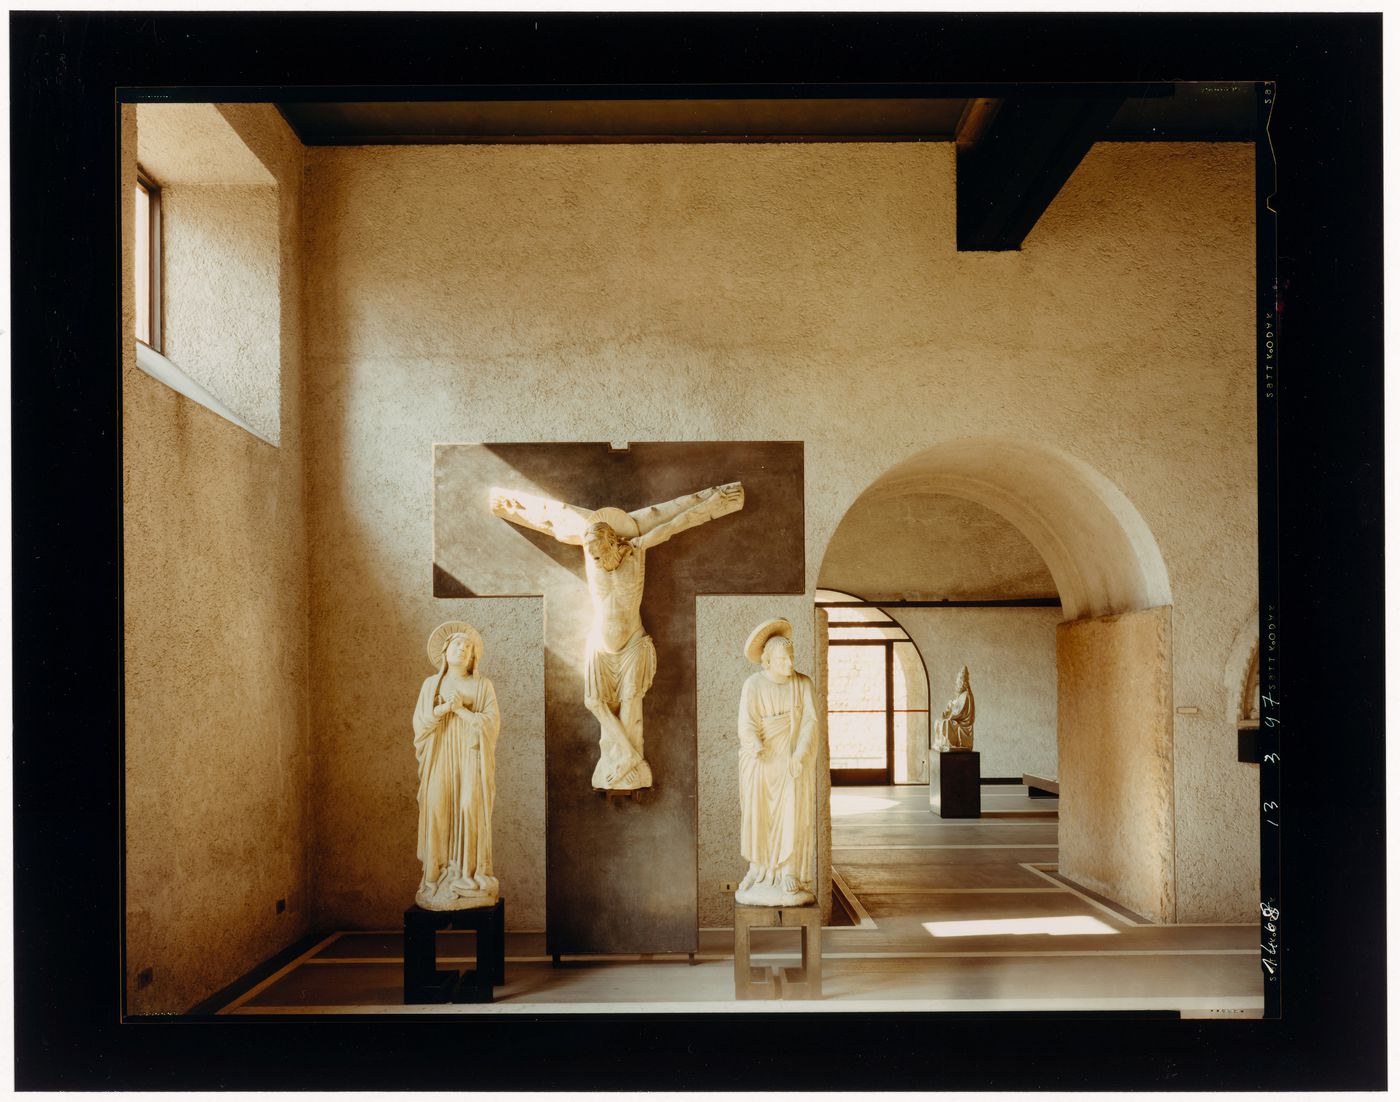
[958,95,1123,252]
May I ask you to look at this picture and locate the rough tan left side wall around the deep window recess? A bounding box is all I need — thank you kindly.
[122,105,311,1014]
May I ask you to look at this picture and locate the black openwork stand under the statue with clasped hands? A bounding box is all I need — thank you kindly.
[403,898,505,1004]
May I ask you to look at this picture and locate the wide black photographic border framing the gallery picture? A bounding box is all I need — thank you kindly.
[10,13,1386,1091]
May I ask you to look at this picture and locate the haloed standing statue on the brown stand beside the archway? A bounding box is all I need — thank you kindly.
[734,620,818,907]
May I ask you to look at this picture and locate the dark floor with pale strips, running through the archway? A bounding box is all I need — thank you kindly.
[212,786,1263,1018]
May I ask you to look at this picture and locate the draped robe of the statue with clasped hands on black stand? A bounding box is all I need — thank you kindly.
[413,674,501,909]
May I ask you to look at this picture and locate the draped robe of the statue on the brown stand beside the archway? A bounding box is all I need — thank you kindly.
[736,671,816,902]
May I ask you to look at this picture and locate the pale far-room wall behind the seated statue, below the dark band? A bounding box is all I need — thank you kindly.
[896,608,1060,777]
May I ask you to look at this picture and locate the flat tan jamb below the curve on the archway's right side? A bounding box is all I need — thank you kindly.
[1057,608,1177,923]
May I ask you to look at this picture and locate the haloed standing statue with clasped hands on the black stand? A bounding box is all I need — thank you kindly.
[413,620,501,910]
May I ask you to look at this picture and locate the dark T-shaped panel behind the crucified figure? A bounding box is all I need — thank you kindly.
[433,441,806,954]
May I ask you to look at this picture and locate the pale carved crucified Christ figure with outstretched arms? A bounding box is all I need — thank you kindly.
[491,482,743,791]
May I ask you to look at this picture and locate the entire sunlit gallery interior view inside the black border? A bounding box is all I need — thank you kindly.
[115,84,1267,1017]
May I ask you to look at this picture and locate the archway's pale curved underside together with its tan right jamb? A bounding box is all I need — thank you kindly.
[817,437,1176,923]
